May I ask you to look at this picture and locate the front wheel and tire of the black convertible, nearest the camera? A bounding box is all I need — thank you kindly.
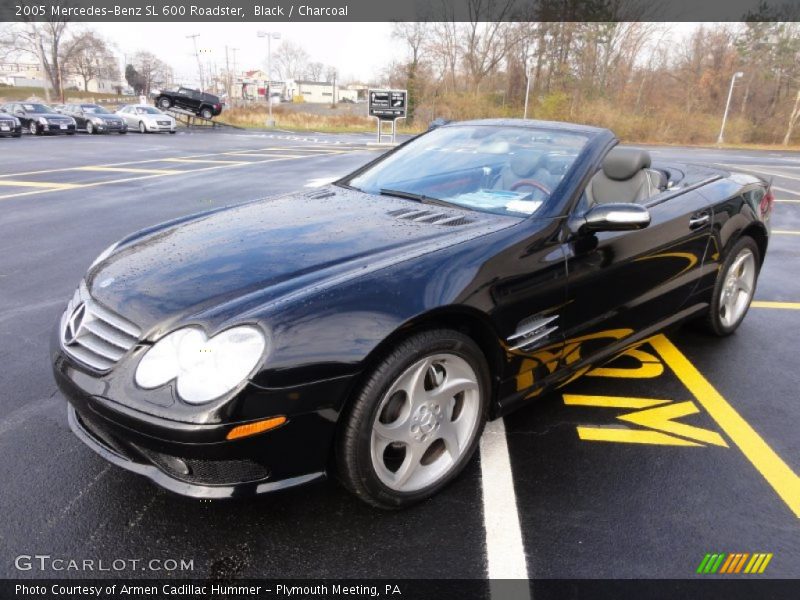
[335,329,490,509]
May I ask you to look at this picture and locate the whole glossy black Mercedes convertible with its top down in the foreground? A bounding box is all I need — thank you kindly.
[52,120,772,508]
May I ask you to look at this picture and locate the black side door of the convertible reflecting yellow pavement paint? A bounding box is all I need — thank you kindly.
[561,190,713,374]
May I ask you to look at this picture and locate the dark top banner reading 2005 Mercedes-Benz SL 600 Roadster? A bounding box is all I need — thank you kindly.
[0,0,800,23]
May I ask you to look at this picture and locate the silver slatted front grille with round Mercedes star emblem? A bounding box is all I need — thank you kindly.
[61,284,142,371]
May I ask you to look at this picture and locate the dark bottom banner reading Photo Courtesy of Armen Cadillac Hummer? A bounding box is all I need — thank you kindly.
[0,577,800,600]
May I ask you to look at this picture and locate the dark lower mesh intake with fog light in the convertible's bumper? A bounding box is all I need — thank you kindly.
[136,445,269,485]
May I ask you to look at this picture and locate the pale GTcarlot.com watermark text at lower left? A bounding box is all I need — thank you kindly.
[14,554,194,573]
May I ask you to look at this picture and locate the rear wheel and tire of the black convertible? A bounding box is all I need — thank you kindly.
[703,235,761,337]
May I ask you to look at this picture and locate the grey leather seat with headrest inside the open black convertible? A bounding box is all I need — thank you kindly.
[586,147,666,206]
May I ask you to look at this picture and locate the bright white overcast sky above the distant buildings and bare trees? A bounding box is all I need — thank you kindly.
[98,23,402,84]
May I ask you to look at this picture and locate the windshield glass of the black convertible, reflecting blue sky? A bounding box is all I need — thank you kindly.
[343,125,587,217]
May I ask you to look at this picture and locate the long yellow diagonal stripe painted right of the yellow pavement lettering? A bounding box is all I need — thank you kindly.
[650,334,800,518]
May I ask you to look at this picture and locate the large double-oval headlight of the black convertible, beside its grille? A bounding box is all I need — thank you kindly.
[135,325,267,404]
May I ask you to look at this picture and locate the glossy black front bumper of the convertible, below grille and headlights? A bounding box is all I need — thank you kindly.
[51,339,349,498]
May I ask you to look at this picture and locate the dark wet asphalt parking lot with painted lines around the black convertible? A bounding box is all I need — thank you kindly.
[0,131,800,579]
